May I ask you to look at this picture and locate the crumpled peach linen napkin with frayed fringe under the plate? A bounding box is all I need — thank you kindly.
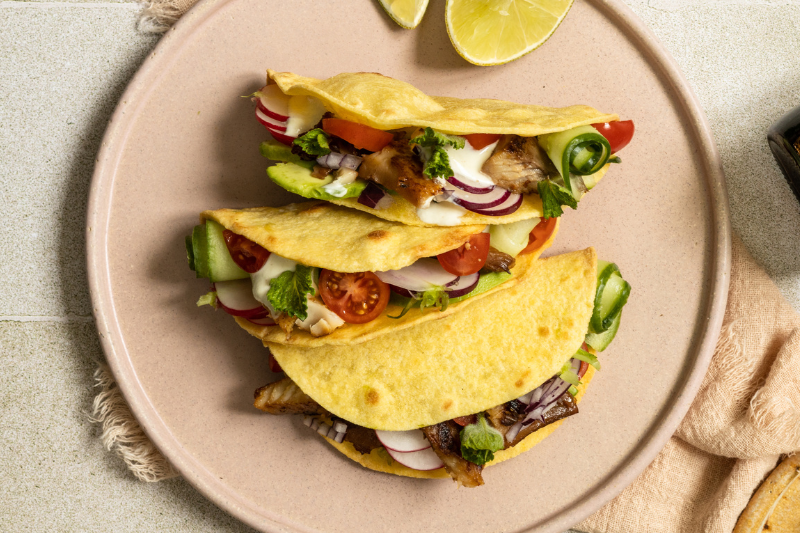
[94,236,800,533]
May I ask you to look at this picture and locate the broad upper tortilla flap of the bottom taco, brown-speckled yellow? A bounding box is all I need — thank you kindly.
[264,248,597,431]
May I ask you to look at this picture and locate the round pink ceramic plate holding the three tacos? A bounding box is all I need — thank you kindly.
[87,0,730,533]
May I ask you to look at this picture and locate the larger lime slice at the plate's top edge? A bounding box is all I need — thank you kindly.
[445,0,573,65]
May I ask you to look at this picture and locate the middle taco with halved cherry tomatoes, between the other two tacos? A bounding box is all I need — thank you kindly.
[186,201,558,347]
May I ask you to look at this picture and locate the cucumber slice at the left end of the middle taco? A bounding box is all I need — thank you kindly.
[186,220,250,282]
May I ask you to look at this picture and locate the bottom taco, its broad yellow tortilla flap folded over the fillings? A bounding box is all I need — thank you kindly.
[255,248,630,487]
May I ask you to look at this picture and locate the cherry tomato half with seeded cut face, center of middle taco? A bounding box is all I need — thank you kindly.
[317,270,391,324]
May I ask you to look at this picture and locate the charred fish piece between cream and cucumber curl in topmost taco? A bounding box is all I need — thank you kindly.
[481,135,558,194]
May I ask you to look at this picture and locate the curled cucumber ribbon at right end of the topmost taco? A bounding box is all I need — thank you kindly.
[537,126,611,199]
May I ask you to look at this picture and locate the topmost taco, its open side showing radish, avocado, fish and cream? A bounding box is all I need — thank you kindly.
[253,70,633,226]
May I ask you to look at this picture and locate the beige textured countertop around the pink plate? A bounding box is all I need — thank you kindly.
[0,0,800,532]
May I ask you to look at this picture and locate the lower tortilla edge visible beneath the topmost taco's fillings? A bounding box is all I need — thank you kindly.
[329,164,610,227]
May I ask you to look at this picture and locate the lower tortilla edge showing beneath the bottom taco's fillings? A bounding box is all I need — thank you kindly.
[323,366,595,479]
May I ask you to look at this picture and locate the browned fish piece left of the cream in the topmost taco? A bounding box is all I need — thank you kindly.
[358,140,442,207]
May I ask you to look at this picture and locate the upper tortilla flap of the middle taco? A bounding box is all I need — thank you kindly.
[200,201,486,272]
